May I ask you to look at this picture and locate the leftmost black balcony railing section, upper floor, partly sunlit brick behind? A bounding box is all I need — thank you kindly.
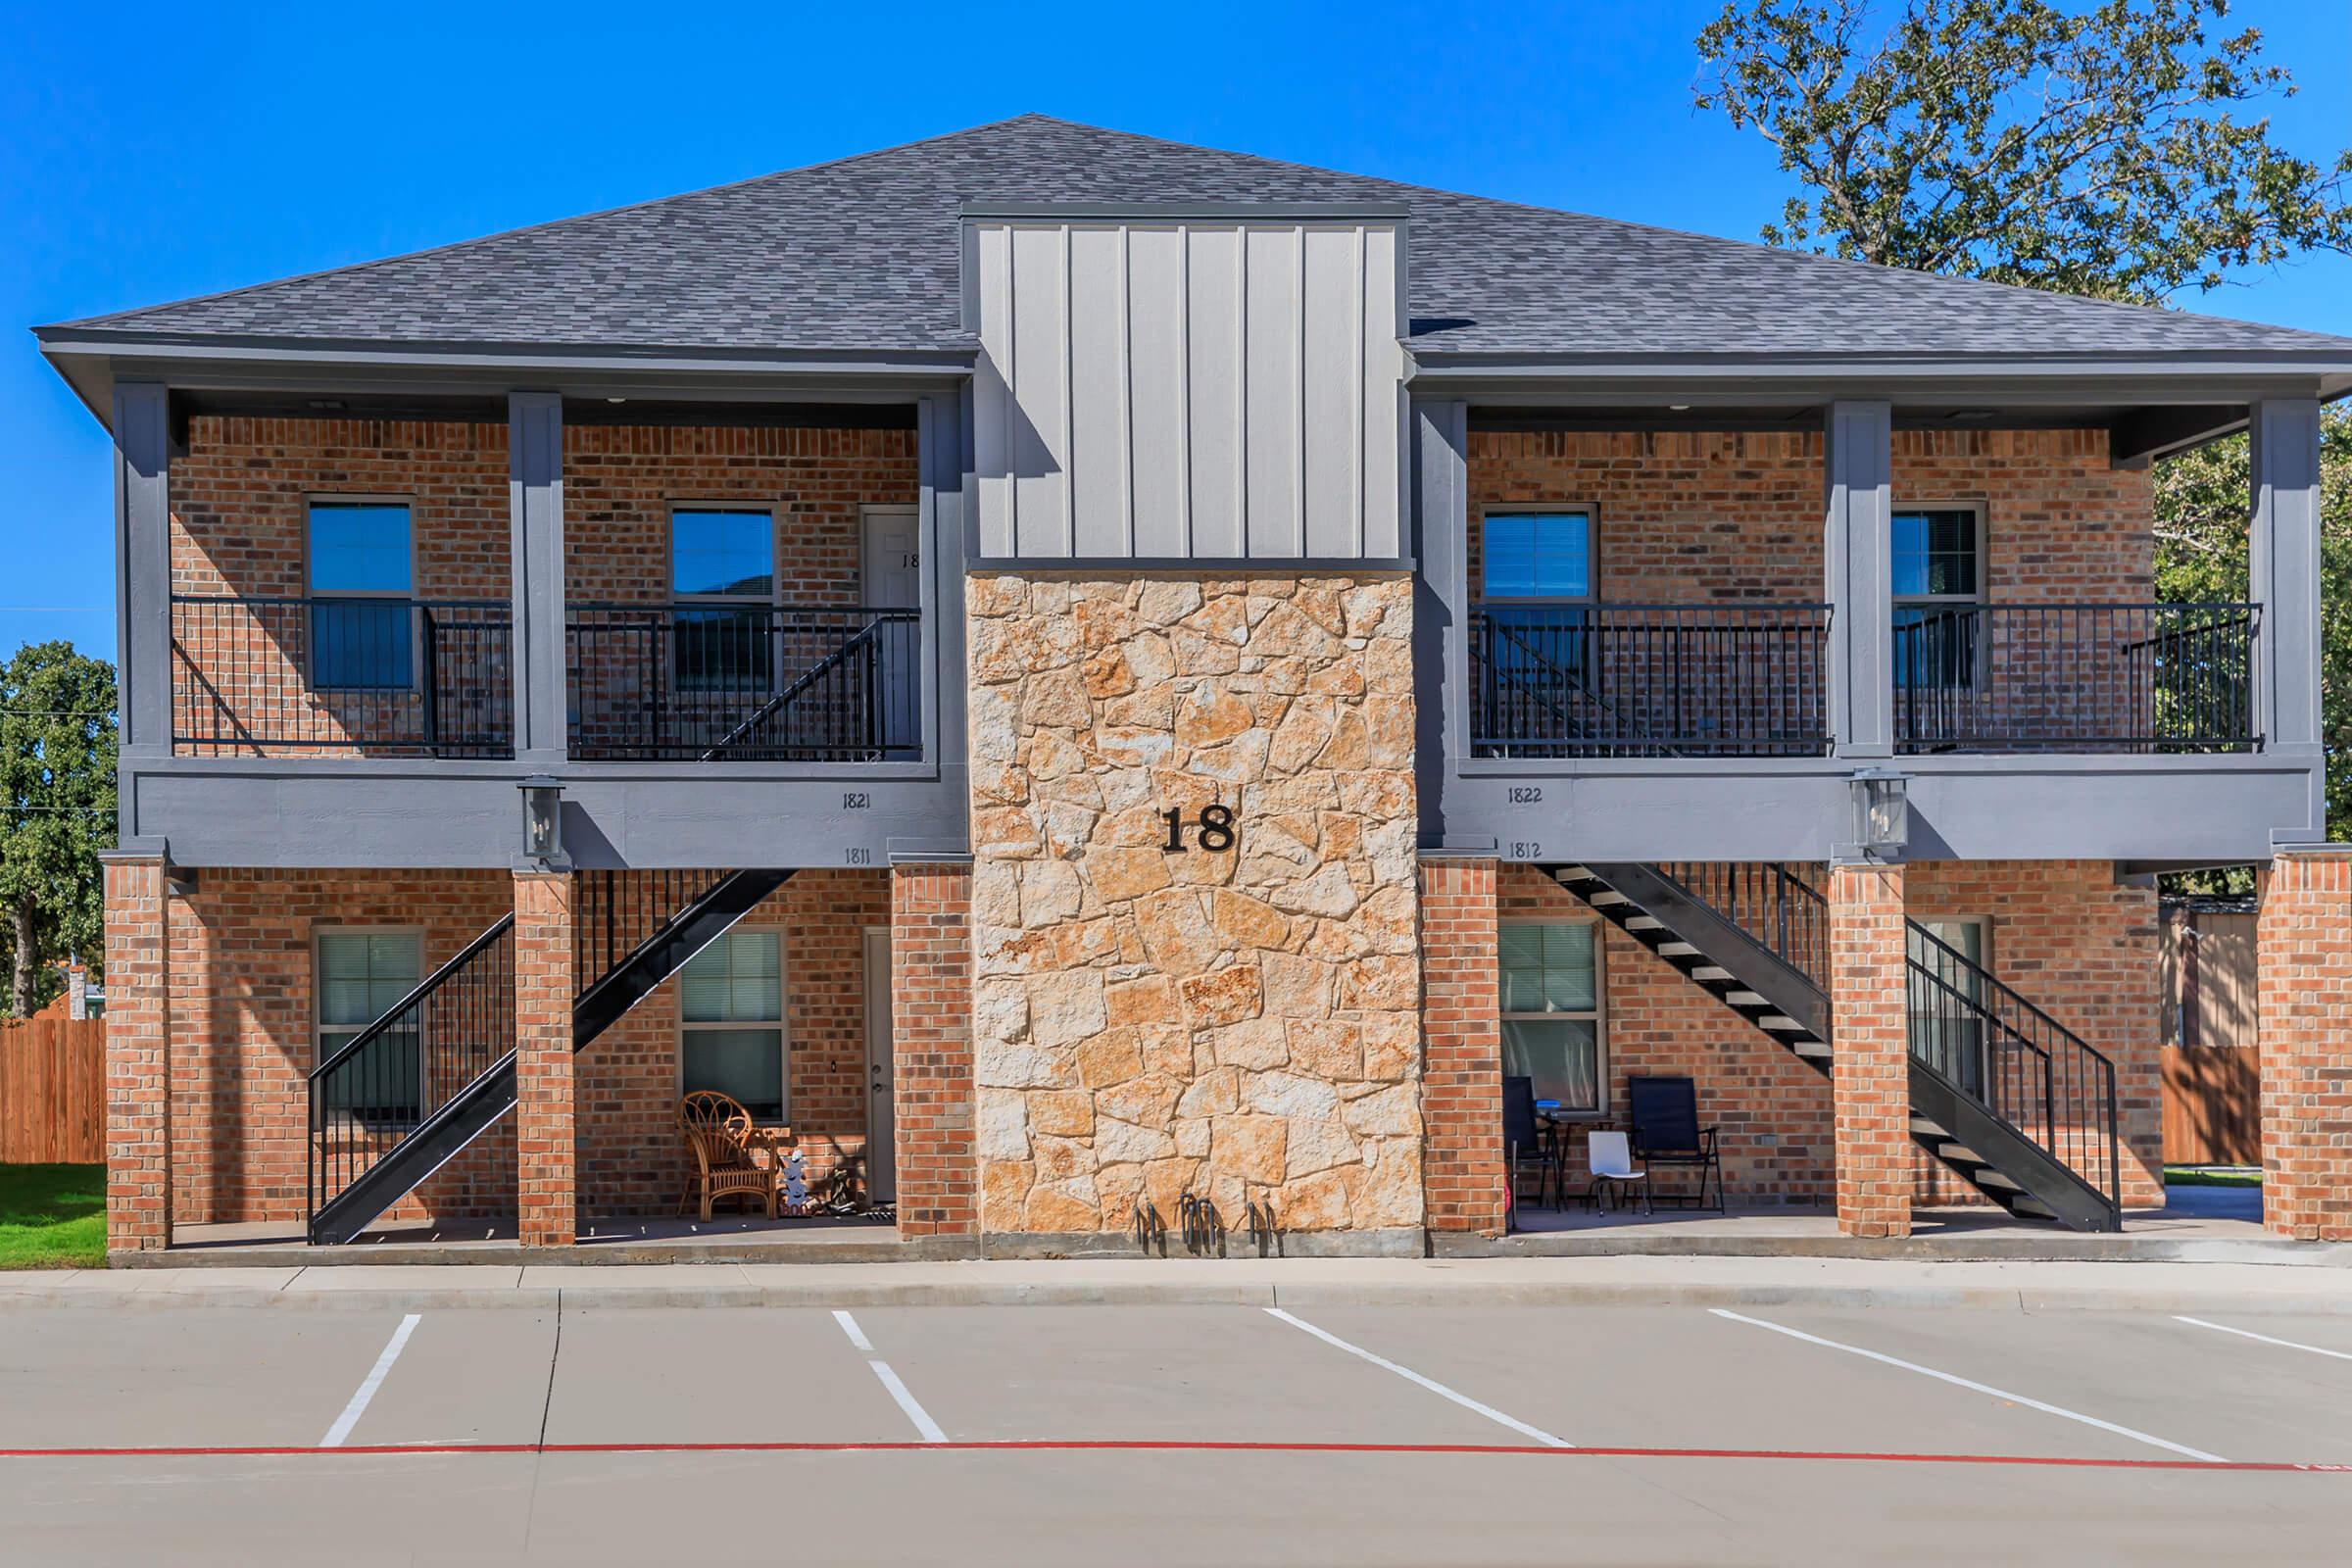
[172,595,515,757]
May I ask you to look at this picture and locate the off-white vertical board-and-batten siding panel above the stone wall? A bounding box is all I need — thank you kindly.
[964,209,1406,562]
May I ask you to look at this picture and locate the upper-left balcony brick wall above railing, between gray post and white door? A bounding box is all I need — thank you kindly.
[564,425,917,604]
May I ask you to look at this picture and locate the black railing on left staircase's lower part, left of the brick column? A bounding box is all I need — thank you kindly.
[306,914,515,1239]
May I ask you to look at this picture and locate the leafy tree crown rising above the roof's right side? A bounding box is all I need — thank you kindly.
[1698,0,2352,303]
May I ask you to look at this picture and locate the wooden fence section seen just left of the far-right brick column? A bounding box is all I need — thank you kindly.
[2162,903,2263,1166]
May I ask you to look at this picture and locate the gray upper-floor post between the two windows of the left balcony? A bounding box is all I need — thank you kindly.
[506,393,569,768]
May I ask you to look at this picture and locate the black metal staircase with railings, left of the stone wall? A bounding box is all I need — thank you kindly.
[306,870,793,1246]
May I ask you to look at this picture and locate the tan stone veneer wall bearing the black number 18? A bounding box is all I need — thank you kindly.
[969,573,1423,1234]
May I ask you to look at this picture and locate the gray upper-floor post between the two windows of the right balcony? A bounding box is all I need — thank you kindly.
[1821,402,1895,760]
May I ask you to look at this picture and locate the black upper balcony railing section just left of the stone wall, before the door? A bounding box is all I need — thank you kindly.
[564,604,922,761]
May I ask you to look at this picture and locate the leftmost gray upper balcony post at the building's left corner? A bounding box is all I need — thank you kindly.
[116,381,172,770]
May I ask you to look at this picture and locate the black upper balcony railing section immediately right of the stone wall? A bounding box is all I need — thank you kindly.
[1470,604,1830,757]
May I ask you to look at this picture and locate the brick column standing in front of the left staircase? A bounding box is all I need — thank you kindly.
[515,872,578,1246]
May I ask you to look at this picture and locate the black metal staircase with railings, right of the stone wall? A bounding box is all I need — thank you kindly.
[1552,862,2124,1232]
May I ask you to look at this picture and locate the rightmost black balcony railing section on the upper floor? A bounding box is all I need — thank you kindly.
[1893,604,2260,753]
